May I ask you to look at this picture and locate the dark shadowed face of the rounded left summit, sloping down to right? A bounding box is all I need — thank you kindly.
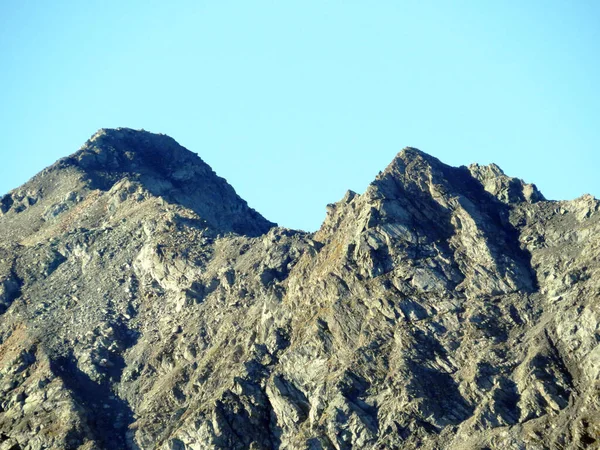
[76,128,275,236]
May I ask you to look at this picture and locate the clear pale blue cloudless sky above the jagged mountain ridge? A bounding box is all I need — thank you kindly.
[0,0,600,230]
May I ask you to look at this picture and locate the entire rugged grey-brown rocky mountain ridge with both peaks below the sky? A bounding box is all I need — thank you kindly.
[0,129,600,450]
